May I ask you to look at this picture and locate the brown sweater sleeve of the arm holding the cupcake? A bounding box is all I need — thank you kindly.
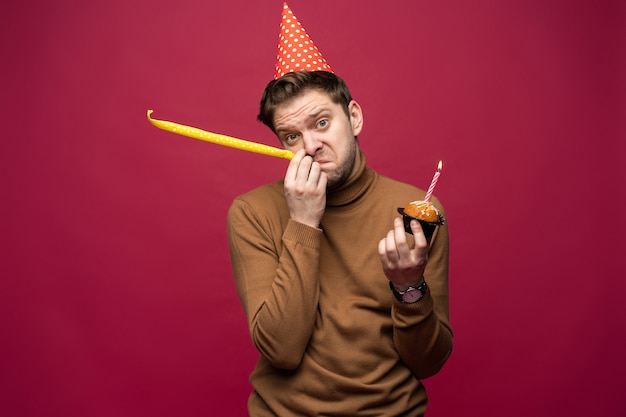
[391,199,452,379]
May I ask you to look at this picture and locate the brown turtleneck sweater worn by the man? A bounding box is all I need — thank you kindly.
[228,154,452,417]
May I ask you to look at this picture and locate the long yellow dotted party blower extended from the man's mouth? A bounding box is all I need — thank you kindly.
[148,110,293,159]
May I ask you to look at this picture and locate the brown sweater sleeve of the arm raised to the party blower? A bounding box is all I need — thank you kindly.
[228,199,322,369]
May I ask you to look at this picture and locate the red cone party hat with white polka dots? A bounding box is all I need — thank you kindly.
[274,3,333,79]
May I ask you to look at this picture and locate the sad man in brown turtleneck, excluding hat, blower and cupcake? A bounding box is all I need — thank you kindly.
[228,6,452,417]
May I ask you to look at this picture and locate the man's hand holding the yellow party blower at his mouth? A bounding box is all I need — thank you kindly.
[285,149,327,227]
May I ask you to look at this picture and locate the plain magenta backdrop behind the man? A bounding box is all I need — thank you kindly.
[0,0,626,417]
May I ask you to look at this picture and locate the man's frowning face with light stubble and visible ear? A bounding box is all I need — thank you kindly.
[274,89,363,189]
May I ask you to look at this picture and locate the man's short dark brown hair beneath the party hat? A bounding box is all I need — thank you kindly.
[257,71,352,133]
